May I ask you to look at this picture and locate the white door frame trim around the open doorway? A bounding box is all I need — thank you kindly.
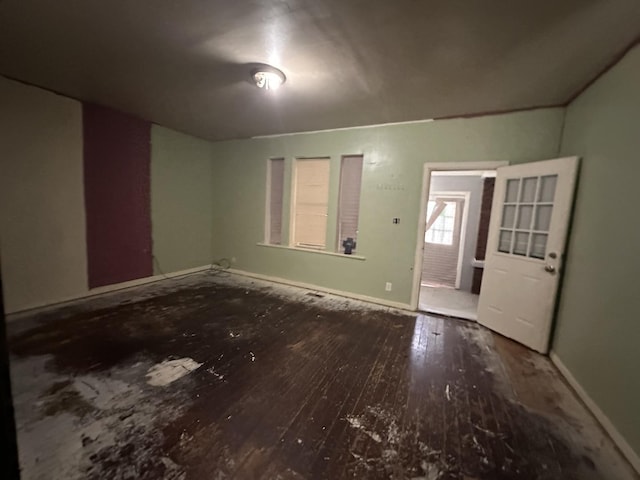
[410,161,509,311]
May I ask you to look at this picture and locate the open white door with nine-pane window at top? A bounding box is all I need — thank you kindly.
[478,157,578,353]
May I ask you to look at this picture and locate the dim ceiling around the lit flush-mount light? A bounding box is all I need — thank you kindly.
[0,0,640,140]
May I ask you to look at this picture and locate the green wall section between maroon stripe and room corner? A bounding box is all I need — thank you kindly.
[151,125,213,274]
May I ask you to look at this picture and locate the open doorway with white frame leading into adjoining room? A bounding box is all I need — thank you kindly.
[412,162,507,320]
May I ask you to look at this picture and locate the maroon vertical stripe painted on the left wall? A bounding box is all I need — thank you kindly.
[82,103,153,288]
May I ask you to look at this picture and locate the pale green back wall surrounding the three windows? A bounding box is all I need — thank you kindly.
[212,108,564,304]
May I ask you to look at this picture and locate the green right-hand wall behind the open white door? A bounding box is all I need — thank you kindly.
[553,47,640,455]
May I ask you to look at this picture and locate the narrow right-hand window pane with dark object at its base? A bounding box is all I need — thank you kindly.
[337,155,362,252]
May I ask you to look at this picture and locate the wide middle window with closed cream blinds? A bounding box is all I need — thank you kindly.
[291,158,330,249]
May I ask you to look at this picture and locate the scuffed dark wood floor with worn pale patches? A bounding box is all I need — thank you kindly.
[9,274,636,480]
